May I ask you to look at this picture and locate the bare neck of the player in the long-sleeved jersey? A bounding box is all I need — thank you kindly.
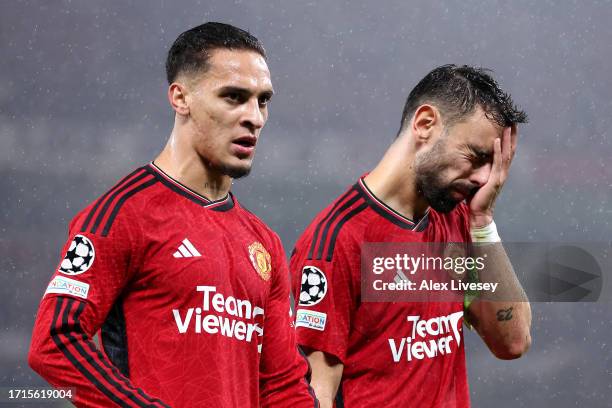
[154,126,232,201]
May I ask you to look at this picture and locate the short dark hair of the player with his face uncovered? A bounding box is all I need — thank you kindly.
[166,22,266,84]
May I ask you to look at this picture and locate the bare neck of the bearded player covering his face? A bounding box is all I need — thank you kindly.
[364,134,428,220]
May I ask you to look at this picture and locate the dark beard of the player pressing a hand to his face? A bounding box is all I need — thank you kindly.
[415,139,462,213]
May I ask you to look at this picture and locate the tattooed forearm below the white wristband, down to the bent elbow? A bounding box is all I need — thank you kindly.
[468,242,531,359]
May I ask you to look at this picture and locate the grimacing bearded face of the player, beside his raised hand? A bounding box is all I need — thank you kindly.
[415,108,503,213]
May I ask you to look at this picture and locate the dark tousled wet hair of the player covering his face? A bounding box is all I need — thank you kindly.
[400,64,528,132]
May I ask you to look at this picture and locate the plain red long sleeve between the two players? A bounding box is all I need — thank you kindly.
[259,239,319,408]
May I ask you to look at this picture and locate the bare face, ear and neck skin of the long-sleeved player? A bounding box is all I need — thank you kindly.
[154,49,274,200]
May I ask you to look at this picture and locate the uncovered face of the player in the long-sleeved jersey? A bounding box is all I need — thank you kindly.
[186,49,273,178]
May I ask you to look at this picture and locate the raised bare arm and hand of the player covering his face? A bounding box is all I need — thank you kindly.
[467,126,531,359]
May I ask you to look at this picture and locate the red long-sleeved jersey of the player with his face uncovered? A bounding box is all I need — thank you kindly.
[30,164,316,407]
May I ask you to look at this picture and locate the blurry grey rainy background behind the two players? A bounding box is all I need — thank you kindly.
[0,0,612,408]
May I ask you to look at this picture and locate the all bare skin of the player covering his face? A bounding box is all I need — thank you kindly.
[307,104,531,407]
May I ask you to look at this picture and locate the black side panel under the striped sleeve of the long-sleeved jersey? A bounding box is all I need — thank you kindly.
[100,298,130,378]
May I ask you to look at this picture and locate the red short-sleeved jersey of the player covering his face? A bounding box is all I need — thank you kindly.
[290,179,469,408]
